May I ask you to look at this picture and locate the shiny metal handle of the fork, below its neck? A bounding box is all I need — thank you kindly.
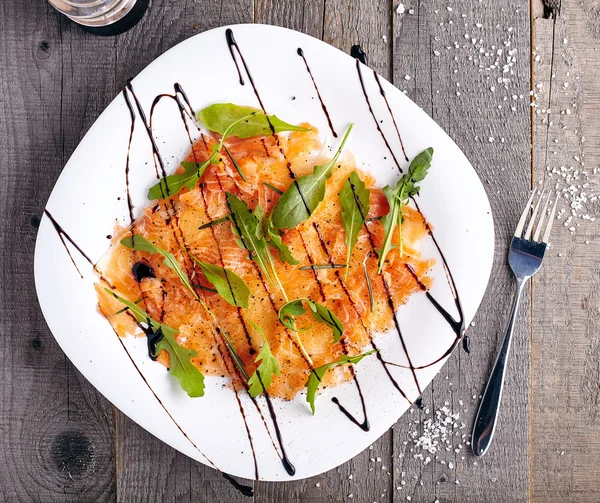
[472,278,529,456]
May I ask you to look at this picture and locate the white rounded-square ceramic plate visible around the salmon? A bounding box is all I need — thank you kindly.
[35,25,493,480]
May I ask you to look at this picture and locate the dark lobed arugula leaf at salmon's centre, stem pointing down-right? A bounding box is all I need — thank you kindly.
[226,192,287,301]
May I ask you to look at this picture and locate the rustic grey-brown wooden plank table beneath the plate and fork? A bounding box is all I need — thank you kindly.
[0,0,600,503]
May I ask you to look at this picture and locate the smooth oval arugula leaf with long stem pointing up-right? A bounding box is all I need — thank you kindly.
[271,124,353,229]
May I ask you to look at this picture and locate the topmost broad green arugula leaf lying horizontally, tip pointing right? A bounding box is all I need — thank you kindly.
[198,103,308,139]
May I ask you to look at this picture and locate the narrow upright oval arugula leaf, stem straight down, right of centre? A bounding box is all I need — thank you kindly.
[340,171,371,279]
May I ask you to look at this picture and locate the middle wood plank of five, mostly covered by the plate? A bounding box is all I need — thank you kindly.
[255,0,392,502]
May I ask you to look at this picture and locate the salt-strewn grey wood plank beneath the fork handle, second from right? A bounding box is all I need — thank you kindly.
[393,1,530,502]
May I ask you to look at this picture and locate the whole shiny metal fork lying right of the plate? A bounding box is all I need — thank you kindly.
[472,191,558,456]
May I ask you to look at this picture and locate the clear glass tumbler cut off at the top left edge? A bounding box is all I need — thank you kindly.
[48,0,149,35]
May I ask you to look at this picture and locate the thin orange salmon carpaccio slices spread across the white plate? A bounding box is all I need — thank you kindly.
[96,124,434,399]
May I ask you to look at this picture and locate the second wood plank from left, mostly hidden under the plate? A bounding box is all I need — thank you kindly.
[113,0,253,503]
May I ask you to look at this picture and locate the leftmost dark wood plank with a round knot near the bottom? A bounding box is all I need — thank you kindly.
[0,2,115,502]
